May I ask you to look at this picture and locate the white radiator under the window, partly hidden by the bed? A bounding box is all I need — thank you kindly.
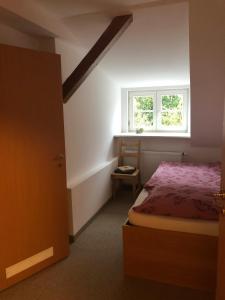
[140,150,184,183]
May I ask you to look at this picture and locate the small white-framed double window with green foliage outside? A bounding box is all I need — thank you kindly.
[128,89,189,132]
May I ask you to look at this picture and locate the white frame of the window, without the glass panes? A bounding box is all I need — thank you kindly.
[125,86,190,133]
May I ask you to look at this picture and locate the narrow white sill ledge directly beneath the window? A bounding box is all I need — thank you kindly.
[114,132,191,139]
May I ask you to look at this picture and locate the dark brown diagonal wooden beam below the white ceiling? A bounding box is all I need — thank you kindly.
[63,15,133,103]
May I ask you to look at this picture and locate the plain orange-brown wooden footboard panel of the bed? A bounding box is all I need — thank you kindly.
[123,221,218,290]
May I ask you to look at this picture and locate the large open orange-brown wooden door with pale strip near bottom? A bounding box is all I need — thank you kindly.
[0,45,68,289]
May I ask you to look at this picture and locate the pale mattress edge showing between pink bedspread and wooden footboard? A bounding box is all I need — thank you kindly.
[128,189,219,236]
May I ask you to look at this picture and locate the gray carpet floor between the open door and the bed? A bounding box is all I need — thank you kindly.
[0,190,214,300]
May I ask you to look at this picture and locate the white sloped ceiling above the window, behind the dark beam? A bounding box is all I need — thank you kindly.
[0,0,189,87]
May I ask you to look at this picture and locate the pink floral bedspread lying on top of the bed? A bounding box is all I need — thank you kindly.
[133,162,221,220]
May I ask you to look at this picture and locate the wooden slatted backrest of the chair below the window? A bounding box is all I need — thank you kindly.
[118,140,141,169]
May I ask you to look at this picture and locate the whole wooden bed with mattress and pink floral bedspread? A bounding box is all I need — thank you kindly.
[123,162,221,290]
